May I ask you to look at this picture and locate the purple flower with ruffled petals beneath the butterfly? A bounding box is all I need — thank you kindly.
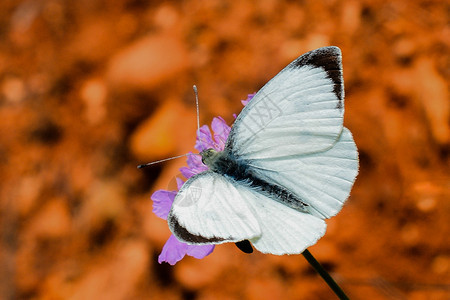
[151,117,231,265]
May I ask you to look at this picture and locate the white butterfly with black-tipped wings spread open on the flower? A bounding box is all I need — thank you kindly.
[167,47,358,255]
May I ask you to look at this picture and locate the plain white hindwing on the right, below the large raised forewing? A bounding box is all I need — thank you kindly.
[250,128,358,218]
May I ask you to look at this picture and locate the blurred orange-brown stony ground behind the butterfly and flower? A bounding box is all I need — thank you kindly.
[0,0,450,299]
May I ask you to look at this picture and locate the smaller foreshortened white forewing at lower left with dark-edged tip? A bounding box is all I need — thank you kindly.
[167,171,261,244]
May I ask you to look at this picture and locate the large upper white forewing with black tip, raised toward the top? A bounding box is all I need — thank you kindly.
[227,47,344,160]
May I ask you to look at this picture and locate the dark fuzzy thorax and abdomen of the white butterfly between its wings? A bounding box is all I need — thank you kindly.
[209,150,308,211]
